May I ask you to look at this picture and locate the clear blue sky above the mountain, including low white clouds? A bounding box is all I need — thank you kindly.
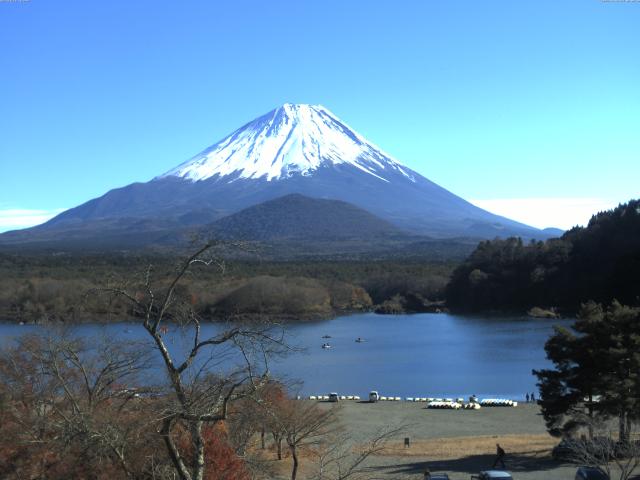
[0,0,640,230]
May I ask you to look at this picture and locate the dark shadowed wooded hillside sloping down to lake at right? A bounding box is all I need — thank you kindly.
[446,200,640,313]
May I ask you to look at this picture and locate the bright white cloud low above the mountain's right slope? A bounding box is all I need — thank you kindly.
[471,197,618,230]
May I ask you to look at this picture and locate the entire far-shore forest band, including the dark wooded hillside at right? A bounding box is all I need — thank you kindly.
[0,200,640,323]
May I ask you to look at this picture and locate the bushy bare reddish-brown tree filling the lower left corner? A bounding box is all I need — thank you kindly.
[0,335,156,478]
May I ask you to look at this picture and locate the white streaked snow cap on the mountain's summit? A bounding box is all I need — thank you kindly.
[159,103,415,181]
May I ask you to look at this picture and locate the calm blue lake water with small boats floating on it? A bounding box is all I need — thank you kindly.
[0,313,571,399]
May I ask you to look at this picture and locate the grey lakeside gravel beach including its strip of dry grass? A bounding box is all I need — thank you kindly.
[308,401,596,480]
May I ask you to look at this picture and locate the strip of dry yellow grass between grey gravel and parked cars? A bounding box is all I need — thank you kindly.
[379,435,558,460]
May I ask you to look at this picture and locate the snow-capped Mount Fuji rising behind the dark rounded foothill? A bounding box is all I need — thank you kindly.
[0,103,549,249]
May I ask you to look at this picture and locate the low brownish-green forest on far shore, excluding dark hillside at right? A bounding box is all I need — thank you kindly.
[0,254,455,323]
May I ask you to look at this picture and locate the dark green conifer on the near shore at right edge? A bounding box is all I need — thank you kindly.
[533,301,640,440]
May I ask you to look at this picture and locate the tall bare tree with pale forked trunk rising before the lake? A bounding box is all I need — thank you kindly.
[102,243,286,480]
